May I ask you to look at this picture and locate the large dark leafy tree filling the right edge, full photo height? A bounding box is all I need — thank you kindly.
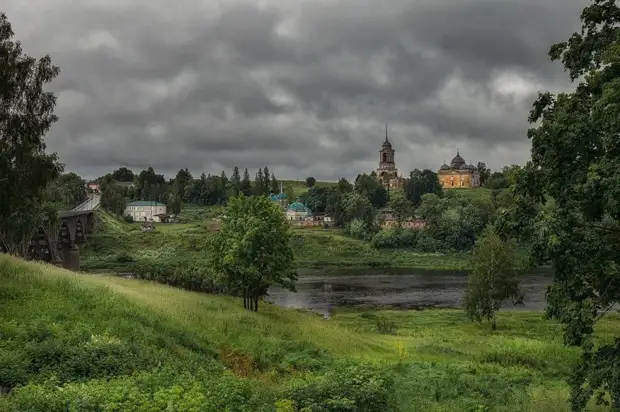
[506,0,620,411]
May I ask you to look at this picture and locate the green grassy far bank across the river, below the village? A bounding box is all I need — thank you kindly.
[81,211,467,271]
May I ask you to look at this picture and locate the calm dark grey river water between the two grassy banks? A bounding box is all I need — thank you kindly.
[266,269,551,315]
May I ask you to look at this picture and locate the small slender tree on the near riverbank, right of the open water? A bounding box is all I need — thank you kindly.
[464,227,523,330]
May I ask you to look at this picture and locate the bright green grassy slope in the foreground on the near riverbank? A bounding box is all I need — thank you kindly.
[0,255,620,412]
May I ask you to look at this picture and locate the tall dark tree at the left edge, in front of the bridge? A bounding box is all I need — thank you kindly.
[0,13,63,255]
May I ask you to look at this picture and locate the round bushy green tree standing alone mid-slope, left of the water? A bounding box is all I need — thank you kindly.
[213,196,297,312]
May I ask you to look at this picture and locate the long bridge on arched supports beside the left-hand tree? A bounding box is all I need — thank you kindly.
[26,193,101,270]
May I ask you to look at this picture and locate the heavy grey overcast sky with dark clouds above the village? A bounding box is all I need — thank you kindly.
[0,0,589,180]
